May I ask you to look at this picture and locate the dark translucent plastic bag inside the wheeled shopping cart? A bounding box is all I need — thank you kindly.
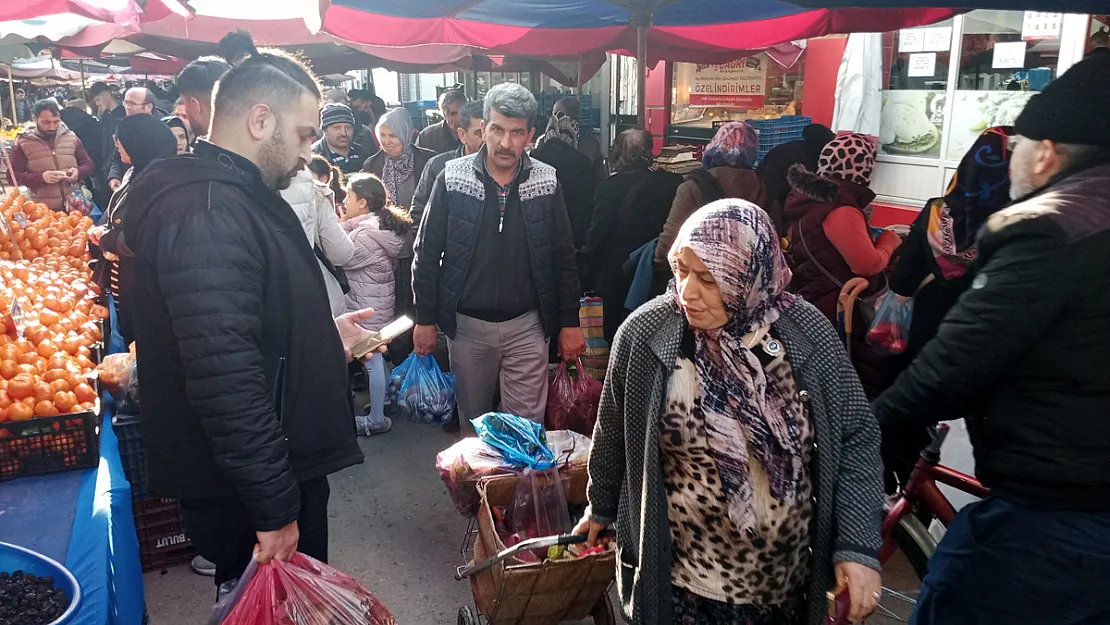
[505,468,571,562]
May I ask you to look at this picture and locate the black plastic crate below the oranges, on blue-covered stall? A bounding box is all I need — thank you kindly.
[0,403,100,481]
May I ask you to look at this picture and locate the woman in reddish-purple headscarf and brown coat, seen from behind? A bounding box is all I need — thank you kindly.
[655,121,764,270]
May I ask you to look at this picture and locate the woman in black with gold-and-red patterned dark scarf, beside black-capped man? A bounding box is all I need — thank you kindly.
[882,127,1020,491]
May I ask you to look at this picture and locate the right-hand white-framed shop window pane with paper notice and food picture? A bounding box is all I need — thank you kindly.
[946,11,1063,161]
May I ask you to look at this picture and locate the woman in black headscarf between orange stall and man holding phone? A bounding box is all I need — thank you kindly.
[89,113,178,344]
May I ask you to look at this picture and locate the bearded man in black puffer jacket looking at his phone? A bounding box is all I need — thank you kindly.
[123,39,363,585]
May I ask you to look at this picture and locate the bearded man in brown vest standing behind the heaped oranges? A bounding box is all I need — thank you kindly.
[11,99,95,211]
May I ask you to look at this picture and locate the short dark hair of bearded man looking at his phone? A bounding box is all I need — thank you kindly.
[213,31,320,119]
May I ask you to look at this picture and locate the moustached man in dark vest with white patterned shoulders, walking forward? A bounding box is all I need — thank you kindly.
[413,83,586,430]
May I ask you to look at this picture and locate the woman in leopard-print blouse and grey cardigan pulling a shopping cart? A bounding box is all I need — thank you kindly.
[576,200,882,625]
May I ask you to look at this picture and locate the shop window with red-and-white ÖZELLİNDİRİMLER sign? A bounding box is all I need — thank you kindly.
[670,44,806,128]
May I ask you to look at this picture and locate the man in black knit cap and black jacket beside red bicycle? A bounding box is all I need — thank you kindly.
[874,54,1110,625]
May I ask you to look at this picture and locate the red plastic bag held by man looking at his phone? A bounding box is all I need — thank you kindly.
[209,553,397,625]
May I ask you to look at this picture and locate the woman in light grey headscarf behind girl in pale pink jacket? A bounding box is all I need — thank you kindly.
[362,109,435,363]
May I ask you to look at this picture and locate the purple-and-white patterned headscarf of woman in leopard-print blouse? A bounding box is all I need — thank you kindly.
[669,199,806,531]
